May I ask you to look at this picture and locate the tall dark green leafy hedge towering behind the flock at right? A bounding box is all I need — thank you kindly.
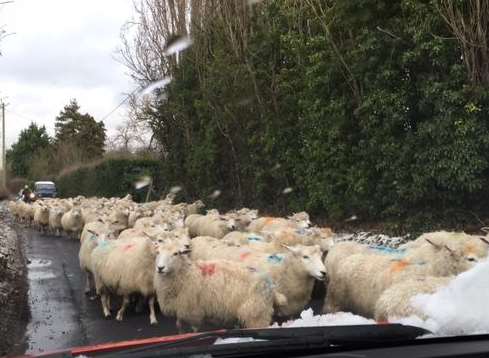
[132,0,489,234]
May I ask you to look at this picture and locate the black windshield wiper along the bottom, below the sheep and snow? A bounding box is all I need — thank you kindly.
[96,324,430,358]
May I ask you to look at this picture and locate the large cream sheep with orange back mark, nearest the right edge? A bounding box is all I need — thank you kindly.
[323,238,487,317]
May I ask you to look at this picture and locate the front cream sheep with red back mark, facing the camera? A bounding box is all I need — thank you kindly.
[154,241,286,331]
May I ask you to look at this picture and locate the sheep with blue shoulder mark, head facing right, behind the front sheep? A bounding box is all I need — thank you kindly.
[191,237,326,317]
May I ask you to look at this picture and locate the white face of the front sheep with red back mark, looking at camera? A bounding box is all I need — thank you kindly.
[155,240,191,275]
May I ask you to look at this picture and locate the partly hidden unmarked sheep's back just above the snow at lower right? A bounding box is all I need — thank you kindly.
[374,276,453,321]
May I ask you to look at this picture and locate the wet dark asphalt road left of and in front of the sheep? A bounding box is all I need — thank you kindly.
[18,229,177,353]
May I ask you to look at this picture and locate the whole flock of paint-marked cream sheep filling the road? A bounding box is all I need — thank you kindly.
[9,195,489,330]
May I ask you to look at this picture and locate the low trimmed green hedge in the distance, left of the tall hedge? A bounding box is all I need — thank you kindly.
[56,159,162,201]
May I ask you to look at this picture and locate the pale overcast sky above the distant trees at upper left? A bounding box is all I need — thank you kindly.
[0,0,134,145]
